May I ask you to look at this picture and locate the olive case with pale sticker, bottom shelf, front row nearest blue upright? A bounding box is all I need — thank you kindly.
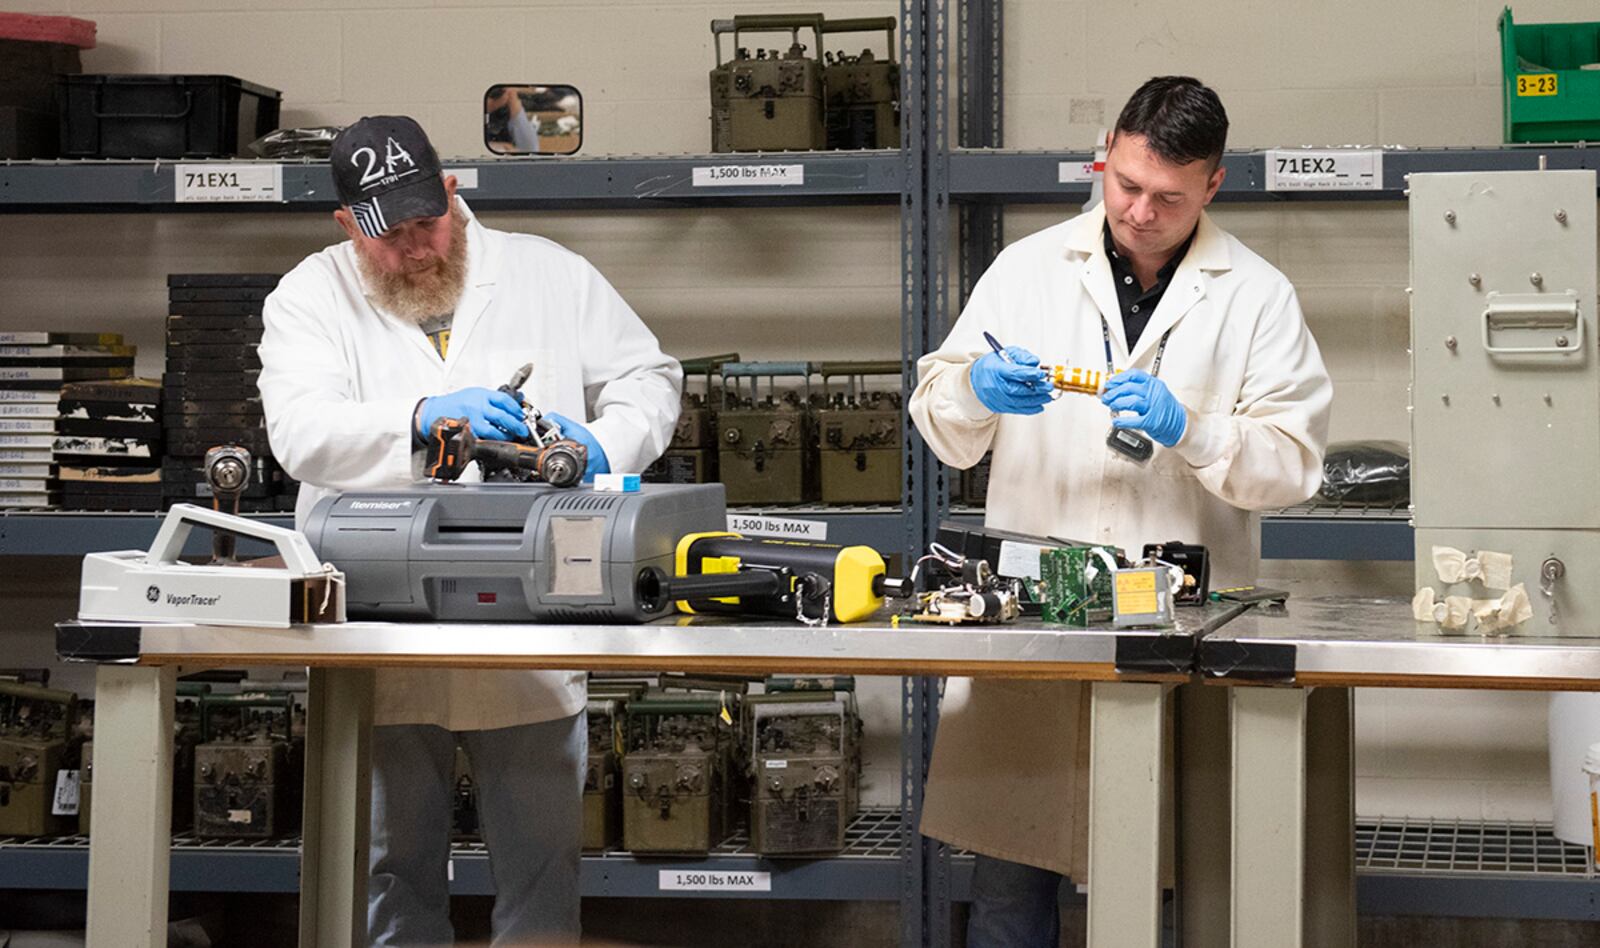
[744,677,861,855]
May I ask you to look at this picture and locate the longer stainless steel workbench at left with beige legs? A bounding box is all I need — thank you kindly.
[58,605,1240,948]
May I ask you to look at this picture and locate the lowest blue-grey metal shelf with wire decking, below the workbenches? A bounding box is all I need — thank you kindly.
[9,807,1600,921]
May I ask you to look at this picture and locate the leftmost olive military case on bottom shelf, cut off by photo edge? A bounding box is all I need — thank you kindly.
[0,681,78,836]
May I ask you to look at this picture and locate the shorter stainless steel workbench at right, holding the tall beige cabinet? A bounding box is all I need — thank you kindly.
[1197,597,1600,948]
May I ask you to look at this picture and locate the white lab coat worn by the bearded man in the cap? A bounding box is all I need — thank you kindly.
[259,202,683,730]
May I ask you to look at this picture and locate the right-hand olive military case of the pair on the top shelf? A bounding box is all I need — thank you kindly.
[822,16,899,149]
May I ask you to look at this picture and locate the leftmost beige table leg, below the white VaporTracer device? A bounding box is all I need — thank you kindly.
[88,665,178,948]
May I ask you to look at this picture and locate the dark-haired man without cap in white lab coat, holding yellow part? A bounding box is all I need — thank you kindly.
[910,77,1333,948]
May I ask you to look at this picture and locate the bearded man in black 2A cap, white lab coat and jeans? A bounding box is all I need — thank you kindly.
[259,115,683,945]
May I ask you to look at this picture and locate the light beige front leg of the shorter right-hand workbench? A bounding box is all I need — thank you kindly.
[1229,687,1306,948]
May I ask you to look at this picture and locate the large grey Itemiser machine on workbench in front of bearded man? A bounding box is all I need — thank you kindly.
[306,484,728,621]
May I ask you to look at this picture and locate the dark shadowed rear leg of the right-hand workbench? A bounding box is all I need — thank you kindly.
[1306,689,1355,948]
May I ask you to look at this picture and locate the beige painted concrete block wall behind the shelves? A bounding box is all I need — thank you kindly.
[0,0,1595,818]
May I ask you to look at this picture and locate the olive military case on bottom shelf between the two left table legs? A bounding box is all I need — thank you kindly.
[194,693,306,839]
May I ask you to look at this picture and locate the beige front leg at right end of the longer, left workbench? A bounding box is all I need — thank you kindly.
[1088,682,1166,948]
